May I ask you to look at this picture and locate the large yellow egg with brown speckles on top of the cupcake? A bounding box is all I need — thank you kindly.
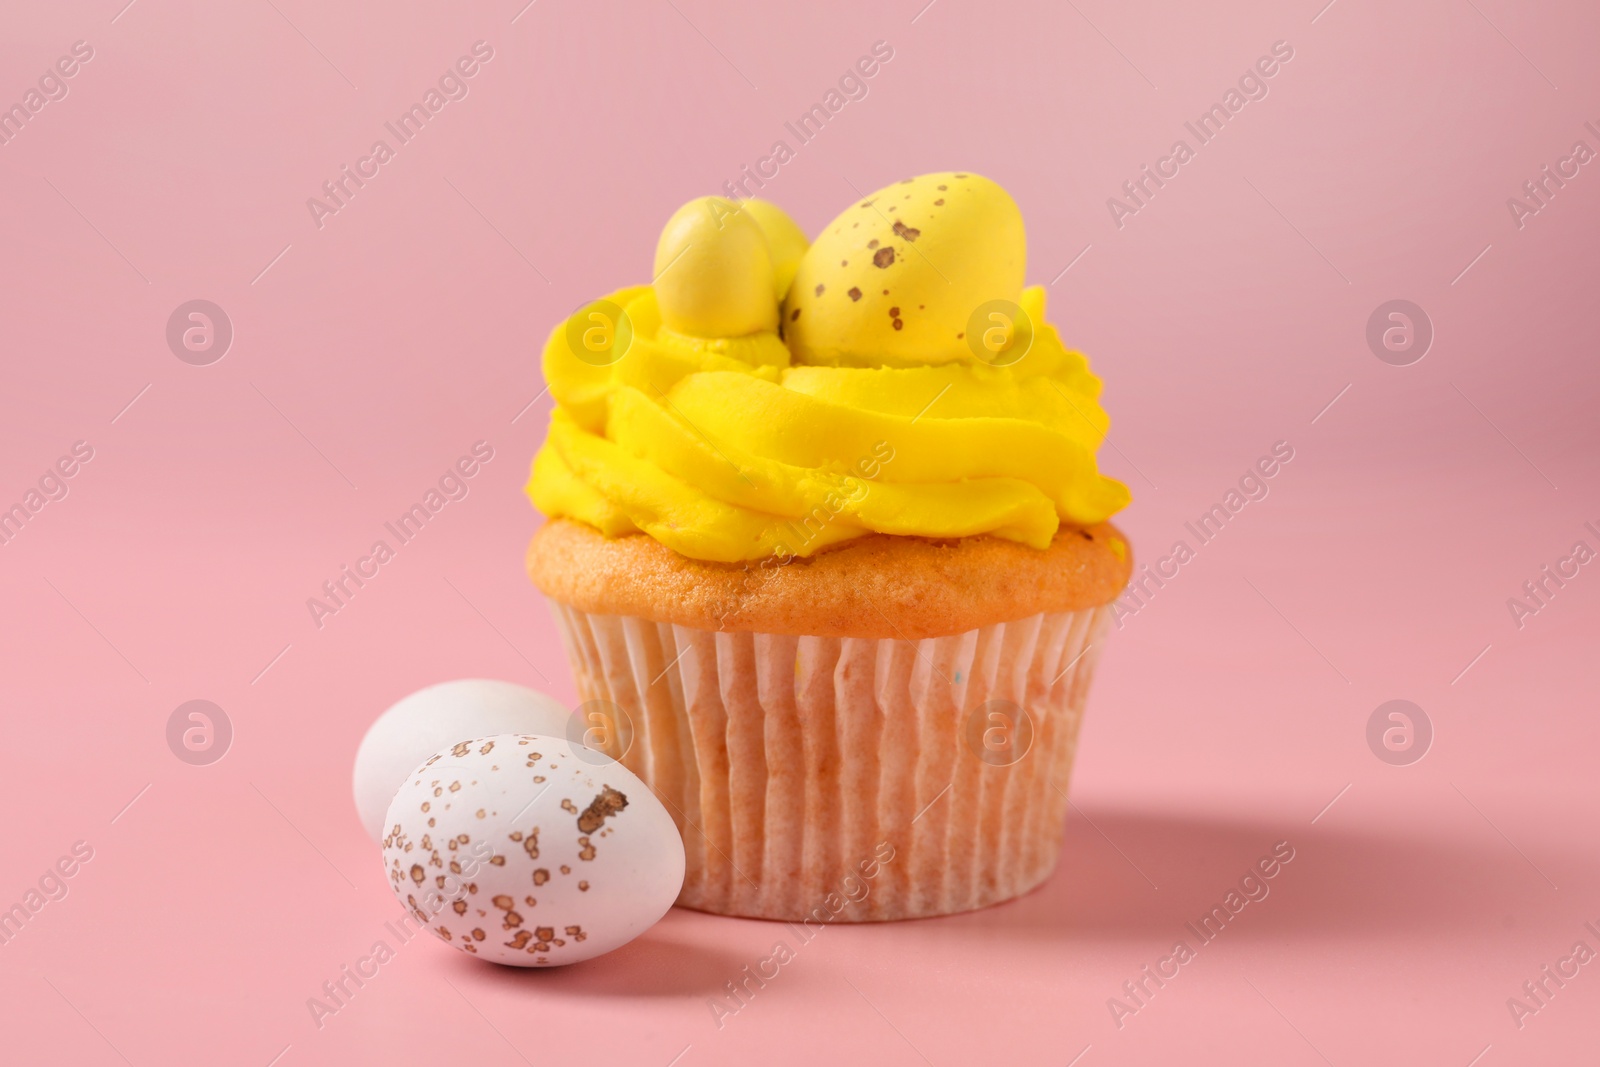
[782,173,1027,366]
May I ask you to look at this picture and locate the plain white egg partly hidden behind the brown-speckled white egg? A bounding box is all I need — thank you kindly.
[354,678,571,841]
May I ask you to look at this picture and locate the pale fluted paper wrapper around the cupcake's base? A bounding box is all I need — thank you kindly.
[552,601,1112,921]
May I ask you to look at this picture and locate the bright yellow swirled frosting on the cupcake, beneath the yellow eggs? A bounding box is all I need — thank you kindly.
[528,286,1130,563]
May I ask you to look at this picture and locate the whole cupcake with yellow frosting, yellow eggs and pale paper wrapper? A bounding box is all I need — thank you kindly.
[526,173,1133,921]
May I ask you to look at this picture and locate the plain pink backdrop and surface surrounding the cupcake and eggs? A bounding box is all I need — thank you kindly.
[0,0,1600,1067]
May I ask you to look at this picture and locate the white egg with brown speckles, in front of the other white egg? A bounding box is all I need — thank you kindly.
[382,734,683,966]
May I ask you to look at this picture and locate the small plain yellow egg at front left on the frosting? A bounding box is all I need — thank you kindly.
[654,197,778,338]
